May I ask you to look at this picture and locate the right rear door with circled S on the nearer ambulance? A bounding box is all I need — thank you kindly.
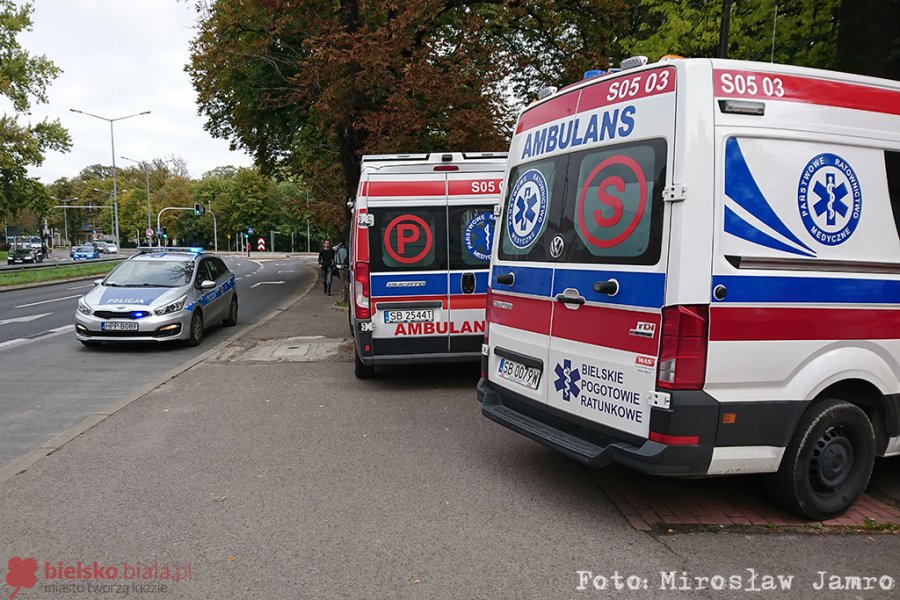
[545,66,676,443]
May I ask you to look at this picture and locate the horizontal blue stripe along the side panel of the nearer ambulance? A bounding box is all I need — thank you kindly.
[712,275,900,304]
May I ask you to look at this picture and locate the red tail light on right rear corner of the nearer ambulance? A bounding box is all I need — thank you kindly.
[656,305,709,390]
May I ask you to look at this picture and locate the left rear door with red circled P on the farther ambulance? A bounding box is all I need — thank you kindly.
[365,165,450,356]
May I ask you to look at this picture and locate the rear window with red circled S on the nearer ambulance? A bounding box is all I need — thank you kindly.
[561,139,666,265]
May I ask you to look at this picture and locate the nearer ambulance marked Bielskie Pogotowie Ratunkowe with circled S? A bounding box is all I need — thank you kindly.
[477,57,900,519]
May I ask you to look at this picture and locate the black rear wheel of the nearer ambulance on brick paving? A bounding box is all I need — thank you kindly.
[766,398,875,521]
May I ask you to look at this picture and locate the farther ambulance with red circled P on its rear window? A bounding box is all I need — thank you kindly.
[350,152,506,379]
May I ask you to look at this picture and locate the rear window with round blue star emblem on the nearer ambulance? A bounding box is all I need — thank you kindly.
[497,156,568,261]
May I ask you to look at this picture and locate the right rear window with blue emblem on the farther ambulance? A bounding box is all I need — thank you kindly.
[449,206,496,271]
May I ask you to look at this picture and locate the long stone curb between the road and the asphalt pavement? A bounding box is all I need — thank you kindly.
[0,264,319,484]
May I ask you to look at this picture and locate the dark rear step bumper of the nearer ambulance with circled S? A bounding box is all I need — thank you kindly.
[476,379,718,477]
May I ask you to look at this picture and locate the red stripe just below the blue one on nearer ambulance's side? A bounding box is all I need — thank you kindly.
[709,306,900,342]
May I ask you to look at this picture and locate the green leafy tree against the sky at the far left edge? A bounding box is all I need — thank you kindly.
[0,0,71,215]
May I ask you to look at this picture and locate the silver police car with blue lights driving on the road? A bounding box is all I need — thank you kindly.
[75,248,238,346]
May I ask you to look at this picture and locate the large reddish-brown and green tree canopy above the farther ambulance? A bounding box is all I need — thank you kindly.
[188,0,629,205]
